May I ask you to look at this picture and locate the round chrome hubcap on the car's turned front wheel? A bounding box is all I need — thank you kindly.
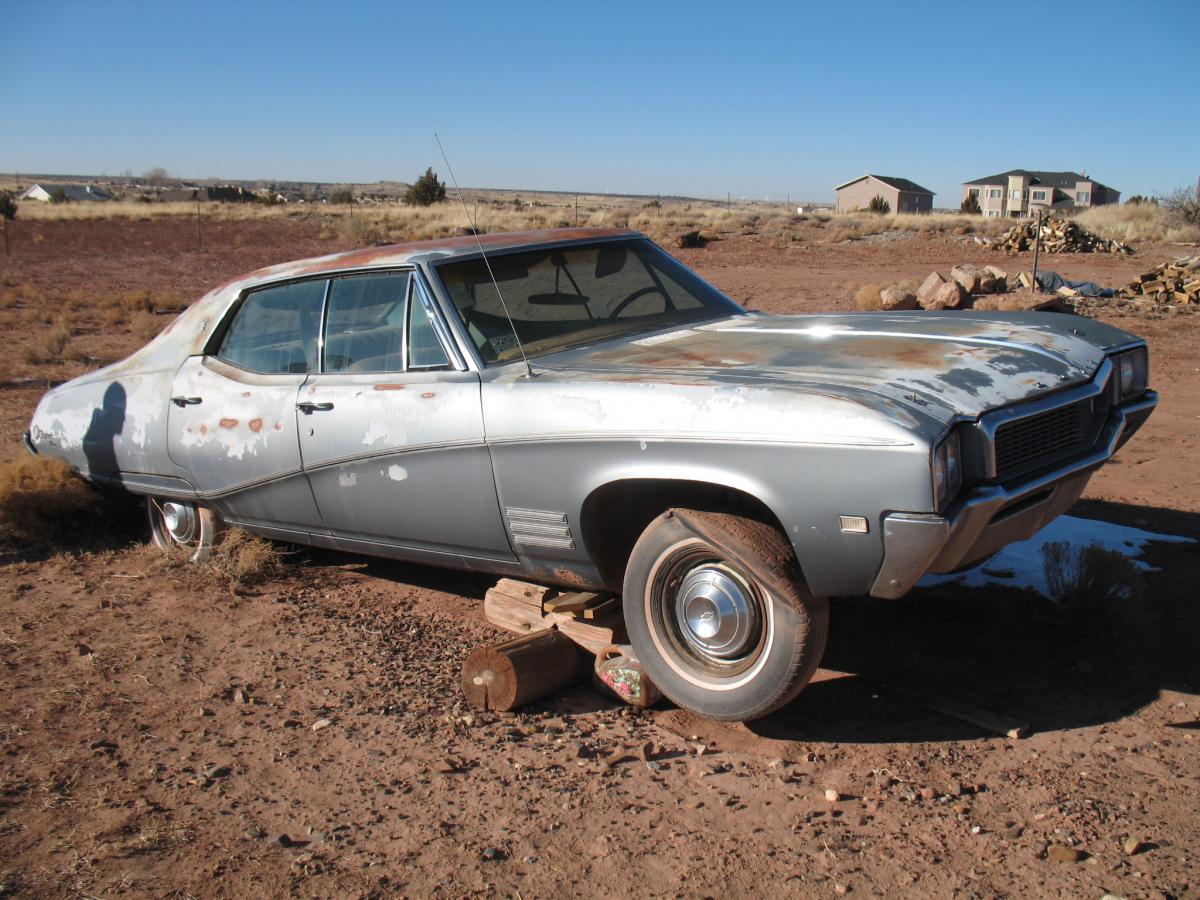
[674,563,761,662]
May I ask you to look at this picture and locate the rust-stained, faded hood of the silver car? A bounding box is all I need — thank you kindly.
[538,312,1135,420]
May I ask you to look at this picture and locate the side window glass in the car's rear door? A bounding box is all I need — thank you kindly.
[216,280,329,374]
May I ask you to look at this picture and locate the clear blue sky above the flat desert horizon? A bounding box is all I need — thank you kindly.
[0,0,1200,205]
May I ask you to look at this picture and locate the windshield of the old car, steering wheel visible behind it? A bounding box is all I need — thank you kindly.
[436,240,744,364]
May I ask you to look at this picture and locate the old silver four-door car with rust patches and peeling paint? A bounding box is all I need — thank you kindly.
[26,229,1157,720]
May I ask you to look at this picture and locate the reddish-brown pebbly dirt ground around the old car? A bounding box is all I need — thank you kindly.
[0,214,1200,900]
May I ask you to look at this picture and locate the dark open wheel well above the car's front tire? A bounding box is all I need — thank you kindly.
[580,479,787,593]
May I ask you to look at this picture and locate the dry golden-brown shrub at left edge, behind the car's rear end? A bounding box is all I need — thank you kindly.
[0,456,101,548]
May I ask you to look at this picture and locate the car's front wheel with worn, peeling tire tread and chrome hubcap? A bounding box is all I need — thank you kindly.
[624,509,829,721]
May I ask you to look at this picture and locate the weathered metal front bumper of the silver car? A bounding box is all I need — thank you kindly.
[870,391,1158,600]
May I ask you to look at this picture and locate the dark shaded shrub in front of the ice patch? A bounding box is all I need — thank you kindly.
[1042,541,1145,618]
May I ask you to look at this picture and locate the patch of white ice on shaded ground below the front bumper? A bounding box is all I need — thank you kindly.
[917,516,1195,596]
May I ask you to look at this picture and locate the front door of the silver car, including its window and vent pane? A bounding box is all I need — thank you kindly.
[299,270,514,559]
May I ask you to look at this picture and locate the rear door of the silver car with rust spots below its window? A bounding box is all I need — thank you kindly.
[167,278,329,540]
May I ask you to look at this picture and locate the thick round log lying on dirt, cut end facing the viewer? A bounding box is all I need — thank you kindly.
[462,629,592,713]
